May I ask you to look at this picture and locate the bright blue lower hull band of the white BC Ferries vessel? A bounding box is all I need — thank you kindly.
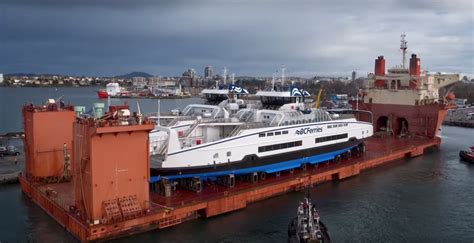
[150,146,355,183]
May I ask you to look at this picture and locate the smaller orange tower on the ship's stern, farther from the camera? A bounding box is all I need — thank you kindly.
[23,103,75,180]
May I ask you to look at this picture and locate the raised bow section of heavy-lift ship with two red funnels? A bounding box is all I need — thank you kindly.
[352,34,459,138]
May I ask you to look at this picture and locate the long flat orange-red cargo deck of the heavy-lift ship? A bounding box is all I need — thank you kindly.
[19,137,441,241]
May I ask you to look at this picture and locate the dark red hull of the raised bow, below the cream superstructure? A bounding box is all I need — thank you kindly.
[352,103,449,138]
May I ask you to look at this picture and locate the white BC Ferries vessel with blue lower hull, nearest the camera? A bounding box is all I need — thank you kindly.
[151,103,373,181]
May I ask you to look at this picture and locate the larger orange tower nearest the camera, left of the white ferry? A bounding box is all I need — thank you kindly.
[74,119,153,224]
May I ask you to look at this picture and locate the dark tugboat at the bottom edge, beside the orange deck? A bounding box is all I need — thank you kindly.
[288,196,331,243]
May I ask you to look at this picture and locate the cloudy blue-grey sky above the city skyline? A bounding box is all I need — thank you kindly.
[0,0,474,77]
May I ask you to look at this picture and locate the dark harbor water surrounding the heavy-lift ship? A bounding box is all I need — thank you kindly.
[0,88,474,243]
